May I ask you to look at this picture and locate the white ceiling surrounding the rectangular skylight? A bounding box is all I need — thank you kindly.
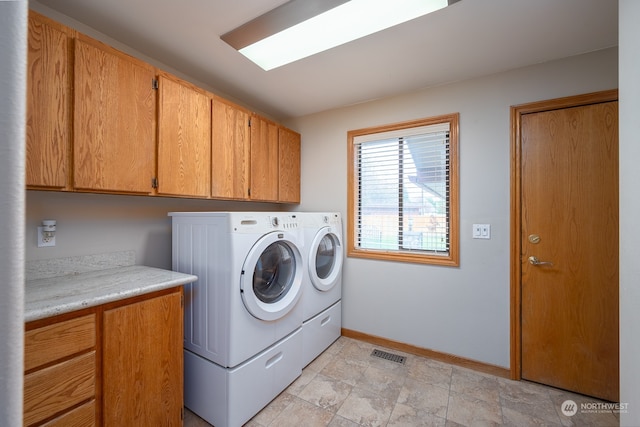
[32,0,618,120]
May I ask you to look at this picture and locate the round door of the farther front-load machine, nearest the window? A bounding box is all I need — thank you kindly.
[309,227,342,291]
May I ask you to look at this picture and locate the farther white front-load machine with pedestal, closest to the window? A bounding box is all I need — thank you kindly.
[298,212,344,366]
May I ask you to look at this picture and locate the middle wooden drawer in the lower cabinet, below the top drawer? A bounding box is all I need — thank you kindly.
[24,351,96,425]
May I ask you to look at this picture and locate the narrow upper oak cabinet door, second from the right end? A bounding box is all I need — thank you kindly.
[250,114,278,202]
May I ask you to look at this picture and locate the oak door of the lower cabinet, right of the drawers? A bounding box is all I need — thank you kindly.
[102,288,183,427]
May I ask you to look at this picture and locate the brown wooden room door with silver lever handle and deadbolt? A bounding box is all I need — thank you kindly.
[520,95,619,401]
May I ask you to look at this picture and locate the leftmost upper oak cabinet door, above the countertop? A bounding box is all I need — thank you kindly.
[26,12,71,189]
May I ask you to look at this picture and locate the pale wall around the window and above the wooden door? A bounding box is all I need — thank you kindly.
[288,48,618,367]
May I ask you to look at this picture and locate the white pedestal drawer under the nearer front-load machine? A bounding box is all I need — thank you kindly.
[184,329,302,427]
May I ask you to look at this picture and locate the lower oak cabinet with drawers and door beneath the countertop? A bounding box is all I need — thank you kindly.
[24,286,183,427]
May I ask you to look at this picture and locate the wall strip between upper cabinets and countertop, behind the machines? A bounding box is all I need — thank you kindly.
[25,191,289,269]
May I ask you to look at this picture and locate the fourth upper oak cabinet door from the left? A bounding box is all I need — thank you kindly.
[211,97,250,199]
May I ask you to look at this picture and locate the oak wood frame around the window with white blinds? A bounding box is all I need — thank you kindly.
[347,113,460,267]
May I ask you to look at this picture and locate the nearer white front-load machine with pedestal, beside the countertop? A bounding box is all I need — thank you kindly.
[169,212,304,427]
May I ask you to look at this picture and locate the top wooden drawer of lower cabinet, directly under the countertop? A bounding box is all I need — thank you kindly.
[24,314,96,371]
